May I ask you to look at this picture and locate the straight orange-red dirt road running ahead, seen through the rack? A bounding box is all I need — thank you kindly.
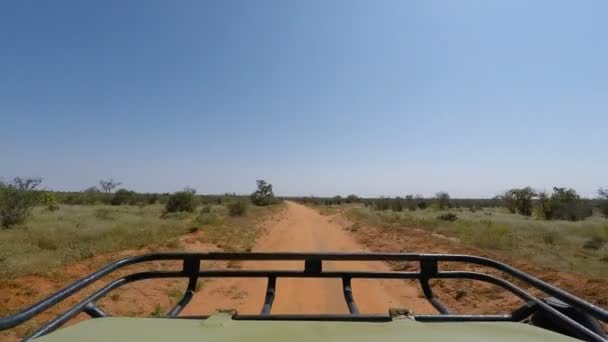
[183,202,435,315]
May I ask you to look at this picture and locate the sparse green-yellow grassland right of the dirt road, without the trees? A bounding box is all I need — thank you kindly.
[346,207,608,278]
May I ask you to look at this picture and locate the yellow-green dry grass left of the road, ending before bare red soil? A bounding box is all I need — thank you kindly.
[0,205,194,278]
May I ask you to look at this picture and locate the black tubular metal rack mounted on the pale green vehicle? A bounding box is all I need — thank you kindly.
[0,253,608,341]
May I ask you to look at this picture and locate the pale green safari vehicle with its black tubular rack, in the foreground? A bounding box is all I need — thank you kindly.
[0,253,608,342]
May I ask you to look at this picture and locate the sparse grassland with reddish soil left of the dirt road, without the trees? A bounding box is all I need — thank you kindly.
[0,204,280,279]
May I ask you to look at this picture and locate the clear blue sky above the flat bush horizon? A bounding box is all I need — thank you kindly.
[0,0,608,197]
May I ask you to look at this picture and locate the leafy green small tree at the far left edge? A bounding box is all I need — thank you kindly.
[0,177,42,228]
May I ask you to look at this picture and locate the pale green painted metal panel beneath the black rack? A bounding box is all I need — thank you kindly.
[36,314,573,342]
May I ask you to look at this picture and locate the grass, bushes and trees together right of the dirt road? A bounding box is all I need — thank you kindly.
[297,187,608,279]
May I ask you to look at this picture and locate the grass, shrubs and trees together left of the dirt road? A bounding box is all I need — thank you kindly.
[0,178,280,279]
